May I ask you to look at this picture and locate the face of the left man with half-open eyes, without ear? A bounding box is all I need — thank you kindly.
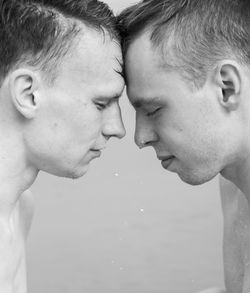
[27,30,125,178]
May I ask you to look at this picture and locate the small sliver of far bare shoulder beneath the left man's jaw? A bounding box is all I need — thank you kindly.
[19,190,34,238]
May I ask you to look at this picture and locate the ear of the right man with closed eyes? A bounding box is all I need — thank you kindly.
[215,60,242,111]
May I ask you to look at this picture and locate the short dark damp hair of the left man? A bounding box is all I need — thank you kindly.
[0,0,119,81]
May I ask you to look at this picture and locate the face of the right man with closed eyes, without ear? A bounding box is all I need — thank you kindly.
[125,33,240,185]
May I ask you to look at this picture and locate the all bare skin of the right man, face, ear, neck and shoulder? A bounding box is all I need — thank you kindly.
[125,31,250,293]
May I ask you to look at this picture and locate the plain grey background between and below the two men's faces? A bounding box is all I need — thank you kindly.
[27,0,223,293]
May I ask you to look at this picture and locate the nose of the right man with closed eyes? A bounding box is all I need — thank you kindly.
[134,114,157,149]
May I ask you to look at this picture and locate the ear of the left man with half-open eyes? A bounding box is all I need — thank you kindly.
[9,69,38,119]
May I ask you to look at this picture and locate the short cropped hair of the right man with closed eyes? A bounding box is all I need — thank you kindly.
[118,0,250,87]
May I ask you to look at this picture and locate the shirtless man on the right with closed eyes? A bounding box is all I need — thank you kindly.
[118,0,250,293]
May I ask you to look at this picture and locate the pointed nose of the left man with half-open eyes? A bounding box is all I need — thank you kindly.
[103,104,126,139]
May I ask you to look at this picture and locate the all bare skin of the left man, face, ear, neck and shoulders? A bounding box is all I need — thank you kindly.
[0,25,125,293]
